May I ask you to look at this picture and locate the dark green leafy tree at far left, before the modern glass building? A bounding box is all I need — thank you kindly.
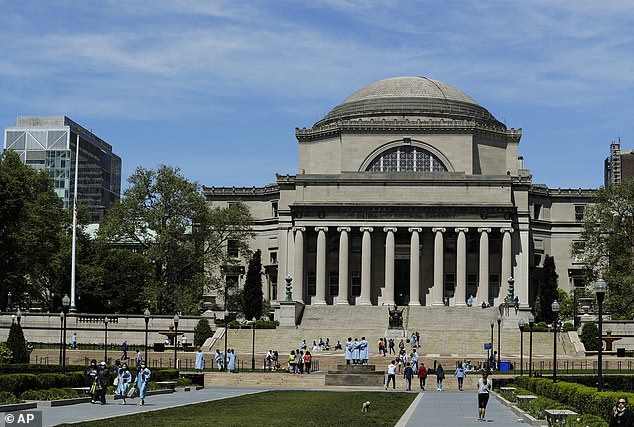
[0,150,70,309]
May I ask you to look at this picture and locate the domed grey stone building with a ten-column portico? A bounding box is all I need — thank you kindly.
[205,77,594,306]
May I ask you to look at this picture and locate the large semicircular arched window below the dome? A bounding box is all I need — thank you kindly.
[367,146,447,172]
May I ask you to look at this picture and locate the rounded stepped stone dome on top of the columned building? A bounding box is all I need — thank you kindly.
[314,76,506,129]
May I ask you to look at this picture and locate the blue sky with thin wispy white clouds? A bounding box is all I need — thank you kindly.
[0,0,634,188]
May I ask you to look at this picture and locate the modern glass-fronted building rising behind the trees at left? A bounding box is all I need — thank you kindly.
[4,116,121,222]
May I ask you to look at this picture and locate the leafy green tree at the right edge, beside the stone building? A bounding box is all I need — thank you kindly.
[571,178,634,319]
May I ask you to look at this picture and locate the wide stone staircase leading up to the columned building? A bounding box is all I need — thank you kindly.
[204,305,579,365]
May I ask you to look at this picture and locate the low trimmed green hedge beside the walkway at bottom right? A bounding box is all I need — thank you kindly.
[515,377,634,421]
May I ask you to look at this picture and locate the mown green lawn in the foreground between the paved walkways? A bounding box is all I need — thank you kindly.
[59,390,416,427]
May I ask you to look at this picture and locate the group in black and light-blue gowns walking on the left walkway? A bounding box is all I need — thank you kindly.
[86,359,152,405]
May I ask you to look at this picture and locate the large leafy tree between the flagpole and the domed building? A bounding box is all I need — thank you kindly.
[99,165,252,314]
